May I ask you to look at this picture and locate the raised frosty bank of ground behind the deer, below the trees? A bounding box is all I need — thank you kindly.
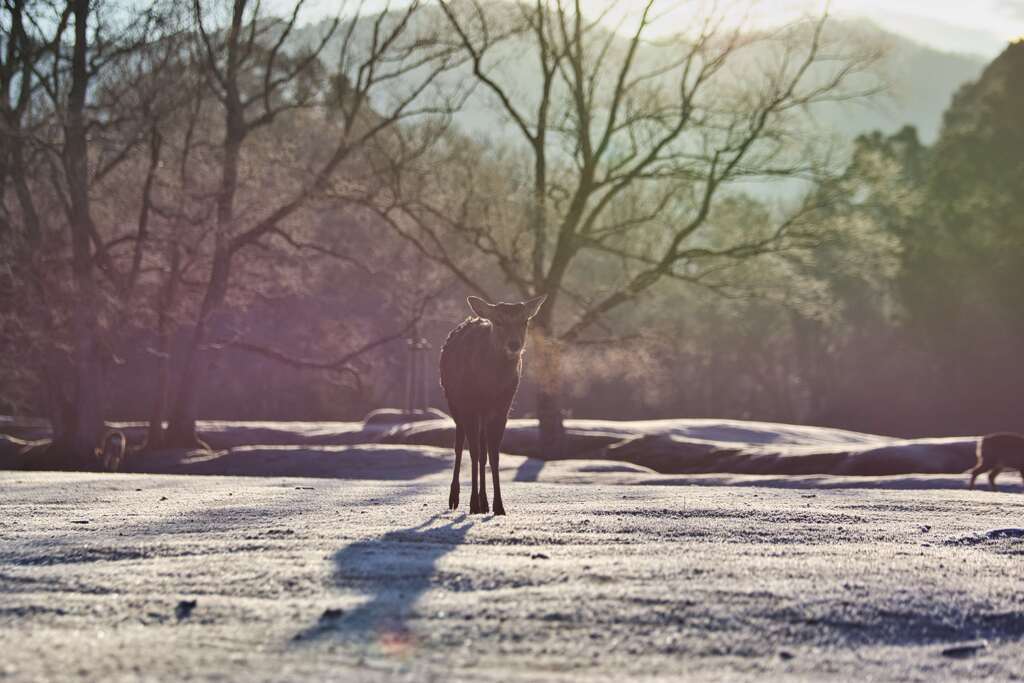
[0,417,976,476]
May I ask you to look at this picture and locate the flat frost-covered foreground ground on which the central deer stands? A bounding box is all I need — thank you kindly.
[0,462,1024,681]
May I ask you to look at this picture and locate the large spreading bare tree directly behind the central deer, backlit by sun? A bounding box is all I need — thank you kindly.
[377,0,876,453]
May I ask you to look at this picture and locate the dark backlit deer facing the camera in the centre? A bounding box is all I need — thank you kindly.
[441,296,546,515]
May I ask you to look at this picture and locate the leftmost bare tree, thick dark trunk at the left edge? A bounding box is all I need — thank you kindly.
[0,0,185,465]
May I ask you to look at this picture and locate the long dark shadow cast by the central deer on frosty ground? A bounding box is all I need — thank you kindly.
[295,514,473,650]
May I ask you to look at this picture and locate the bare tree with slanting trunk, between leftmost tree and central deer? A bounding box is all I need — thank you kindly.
[158,0,453,445]
